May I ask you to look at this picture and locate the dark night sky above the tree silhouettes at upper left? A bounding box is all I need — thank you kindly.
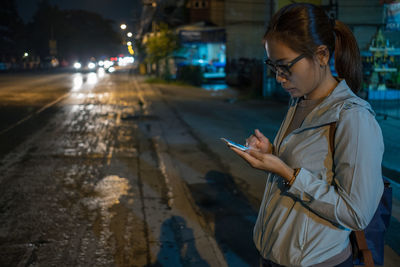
[16,0,141,24]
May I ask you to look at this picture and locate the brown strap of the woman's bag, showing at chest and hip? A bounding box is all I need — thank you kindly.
[329,121,374,267]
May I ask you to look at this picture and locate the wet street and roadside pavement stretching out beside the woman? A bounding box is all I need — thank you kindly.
[0,72,399,266]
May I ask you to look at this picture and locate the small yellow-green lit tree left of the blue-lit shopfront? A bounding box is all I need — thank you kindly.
[145,24,179,77]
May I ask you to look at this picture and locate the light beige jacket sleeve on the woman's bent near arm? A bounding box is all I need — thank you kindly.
[288,107,384,230]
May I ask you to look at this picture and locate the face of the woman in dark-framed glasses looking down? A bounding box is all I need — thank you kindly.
[265,38,322,99]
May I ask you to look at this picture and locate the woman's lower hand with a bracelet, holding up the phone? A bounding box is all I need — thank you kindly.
[229,147,294,181]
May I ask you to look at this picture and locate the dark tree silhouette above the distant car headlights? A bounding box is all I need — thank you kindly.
[28,0,121,60]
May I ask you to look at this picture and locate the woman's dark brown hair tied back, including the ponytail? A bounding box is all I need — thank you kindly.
[264,3,362,92]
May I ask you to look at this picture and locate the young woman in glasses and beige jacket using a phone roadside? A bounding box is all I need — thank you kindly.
[231,4,384,267]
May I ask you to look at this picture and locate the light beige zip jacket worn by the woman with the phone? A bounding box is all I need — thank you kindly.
[253,81,384,266]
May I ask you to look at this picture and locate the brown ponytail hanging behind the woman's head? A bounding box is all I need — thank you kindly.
[334,20,362,93]
